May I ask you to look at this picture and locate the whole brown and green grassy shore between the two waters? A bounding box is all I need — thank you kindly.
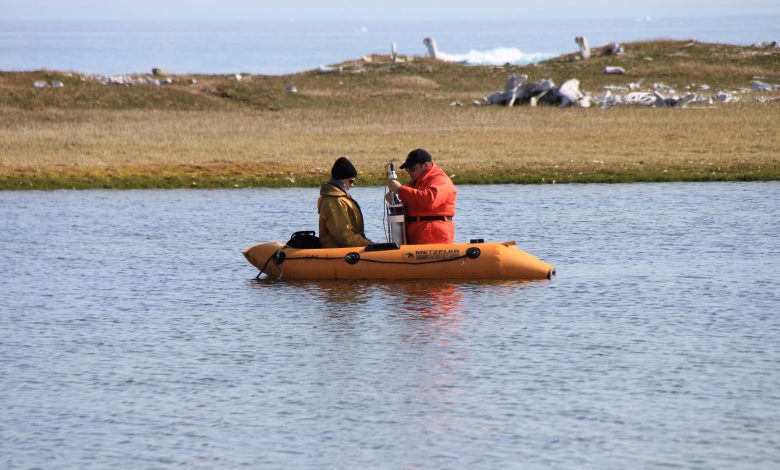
[0,41,780,189]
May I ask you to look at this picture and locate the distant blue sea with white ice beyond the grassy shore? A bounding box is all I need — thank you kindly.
[0,16,780,75]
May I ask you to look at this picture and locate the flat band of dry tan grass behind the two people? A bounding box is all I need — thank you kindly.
[0,103,780,188]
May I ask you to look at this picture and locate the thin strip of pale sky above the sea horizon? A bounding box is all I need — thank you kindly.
[0,0,780,20]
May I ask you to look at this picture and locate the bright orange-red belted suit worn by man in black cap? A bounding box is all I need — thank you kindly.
[398,163,458,245]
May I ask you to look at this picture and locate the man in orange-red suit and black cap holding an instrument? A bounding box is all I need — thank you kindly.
[387,149,457,245]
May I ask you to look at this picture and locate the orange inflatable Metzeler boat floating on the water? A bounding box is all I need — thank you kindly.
[244,242,555,279]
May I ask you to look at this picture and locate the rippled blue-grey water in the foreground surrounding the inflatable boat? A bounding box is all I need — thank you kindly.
[0,183,780,469]
